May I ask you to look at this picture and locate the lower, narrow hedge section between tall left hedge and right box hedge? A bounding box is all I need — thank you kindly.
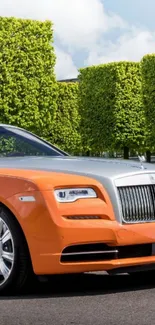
[51,83,81,154]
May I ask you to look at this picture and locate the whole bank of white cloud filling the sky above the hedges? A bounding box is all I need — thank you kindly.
[0,0,155,79]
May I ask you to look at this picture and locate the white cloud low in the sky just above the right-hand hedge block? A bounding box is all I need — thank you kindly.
[85,28,155,65]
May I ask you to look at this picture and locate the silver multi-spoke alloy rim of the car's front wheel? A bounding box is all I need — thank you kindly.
[0,218,14,286]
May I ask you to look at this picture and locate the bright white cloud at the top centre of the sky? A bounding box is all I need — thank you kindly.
[52,0,125,51]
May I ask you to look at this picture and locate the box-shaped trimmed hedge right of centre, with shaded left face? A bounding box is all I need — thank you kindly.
[79,62,145,158]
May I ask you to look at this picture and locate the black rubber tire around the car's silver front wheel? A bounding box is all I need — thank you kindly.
[0,206,33,294]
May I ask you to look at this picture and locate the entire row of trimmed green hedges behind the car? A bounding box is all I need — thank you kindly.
[0,17,151,157]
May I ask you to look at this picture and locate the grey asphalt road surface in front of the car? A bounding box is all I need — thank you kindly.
[0,273,155,325]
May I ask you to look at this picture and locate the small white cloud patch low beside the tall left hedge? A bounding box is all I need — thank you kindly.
[55,47,78,79]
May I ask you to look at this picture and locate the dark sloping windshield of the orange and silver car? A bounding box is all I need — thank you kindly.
[0,126,68,157]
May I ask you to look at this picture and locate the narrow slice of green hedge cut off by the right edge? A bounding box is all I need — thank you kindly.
[141,54,155,150]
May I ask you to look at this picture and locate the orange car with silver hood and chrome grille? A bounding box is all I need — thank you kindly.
[0,125,155,292]
